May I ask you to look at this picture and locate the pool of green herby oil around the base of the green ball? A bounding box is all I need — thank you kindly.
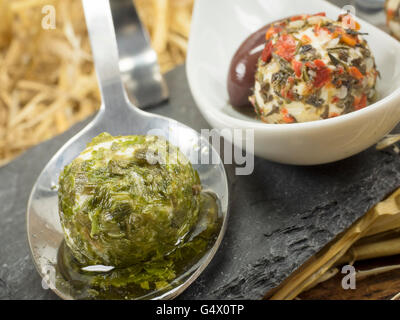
[55,191,222,299]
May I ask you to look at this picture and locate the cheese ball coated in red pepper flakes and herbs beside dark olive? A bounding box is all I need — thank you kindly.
[249,13,379,123]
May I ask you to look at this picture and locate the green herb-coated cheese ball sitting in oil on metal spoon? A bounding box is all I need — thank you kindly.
[58,133,200,267]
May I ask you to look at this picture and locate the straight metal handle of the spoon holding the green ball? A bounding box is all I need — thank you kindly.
[82,0,130,112]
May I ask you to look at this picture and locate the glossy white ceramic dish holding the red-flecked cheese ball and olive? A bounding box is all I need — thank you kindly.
[186,0,400,165]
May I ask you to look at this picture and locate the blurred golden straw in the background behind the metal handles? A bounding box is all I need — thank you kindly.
[0,0,193,166]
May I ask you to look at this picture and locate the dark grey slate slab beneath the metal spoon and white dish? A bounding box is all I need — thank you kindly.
[0,67,400,299]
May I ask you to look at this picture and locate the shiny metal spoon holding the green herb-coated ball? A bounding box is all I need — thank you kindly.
[27,0,228,299]
